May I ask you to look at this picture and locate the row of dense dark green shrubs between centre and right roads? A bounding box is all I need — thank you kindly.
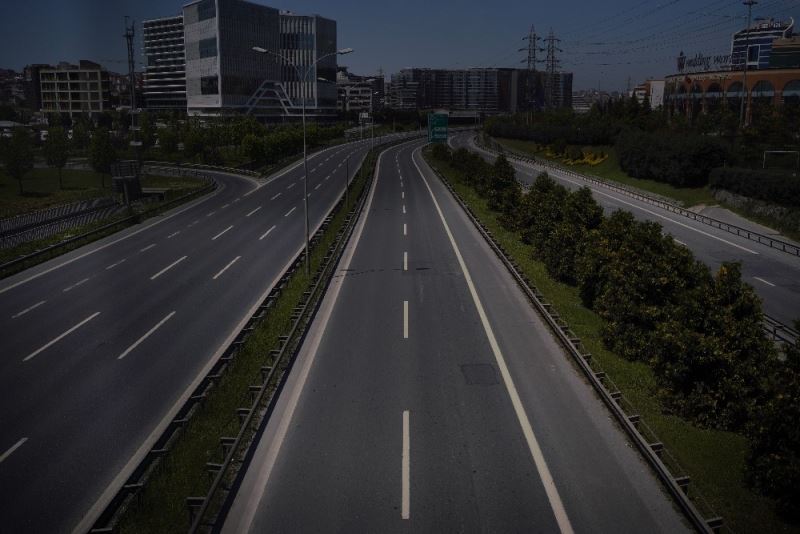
[432,146,800,518]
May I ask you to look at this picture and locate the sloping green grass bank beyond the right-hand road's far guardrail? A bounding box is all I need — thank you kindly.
[496,138,718,207]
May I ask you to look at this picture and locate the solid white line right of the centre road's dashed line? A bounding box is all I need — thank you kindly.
[411,149,573,534]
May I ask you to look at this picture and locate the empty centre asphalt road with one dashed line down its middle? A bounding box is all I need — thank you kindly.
[223,143,687,533]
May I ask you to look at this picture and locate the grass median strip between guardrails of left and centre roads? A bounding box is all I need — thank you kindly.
[118,149,375,533]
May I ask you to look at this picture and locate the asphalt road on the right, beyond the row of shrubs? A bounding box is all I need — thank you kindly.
[452,133,800,326]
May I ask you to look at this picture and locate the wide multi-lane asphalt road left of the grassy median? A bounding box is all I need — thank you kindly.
[0,132,412,533]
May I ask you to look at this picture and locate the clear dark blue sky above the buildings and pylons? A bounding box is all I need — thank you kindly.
[0,0,800,91]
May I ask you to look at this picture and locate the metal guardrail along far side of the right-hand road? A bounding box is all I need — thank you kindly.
[478,140,800,257]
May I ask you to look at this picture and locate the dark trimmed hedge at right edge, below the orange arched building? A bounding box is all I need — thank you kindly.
[709,167,800,207]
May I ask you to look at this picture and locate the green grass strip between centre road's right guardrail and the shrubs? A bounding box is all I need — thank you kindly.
[426,148,800,532]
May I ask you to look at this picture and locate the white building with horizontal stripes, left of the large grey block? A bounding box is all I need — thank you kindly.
[141,14,186,112]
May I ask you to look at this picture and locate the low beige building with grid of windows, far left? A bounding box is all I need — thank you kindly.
[39,59,110,118]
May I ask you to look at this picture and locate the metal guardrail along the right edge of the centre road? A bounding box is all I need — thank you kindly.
[431,161,727,534]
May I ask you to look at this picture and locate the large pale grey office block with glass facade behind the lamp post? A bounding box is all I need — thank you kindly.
[183,0,337,120]
